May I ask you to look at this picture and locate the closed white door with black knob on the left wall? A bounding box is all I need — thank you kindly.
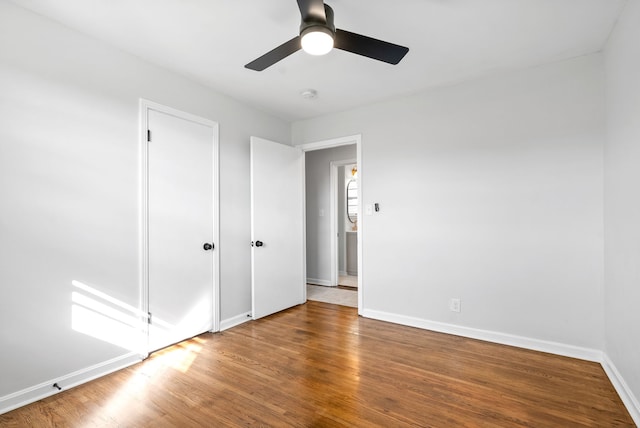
[147,109,217,352]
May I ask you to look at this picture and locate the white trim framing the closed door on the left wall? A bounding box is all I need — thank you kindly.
[138,98,220,359]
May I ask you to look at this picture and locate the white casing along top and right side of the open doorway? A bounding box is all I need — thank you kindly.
[296,134,365,315]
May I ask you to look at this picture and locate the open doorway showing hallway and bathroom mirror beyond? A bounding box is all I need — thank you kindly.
[302,136,362,308]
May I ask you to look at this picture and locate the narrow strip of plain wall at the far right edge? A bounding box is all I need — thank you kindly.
[605,0,640,416]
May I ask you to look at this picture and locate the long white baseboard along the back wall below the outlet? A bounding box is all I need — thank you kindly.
[362,309,602,363]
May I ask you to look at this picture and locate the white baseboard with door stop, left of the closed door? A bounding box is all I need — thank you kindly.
[0,352,142,414]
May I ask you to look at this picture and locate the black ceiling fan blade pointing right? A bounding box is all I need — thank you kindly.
[333,29,409,65]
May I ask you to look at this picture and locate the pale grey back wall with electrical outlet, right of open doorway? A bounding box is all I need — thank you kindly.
[292,55,604,352]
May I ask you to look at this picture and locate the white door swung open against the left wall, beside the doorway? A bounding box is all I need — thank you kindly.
[251,137,306,319]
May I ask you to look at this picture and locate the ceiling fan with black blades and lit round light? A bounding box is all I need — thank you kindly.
[245,0,409,71]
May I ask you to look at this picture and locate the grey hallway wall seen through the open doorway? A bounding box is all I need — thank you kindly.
[305,144,356,285]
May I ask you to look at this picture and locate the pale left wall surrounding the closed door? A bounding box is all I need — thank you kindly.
[0,0,290,404]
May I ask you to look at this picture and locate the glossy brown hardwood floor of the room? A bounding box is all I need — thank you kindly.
[0,302,634,427]
